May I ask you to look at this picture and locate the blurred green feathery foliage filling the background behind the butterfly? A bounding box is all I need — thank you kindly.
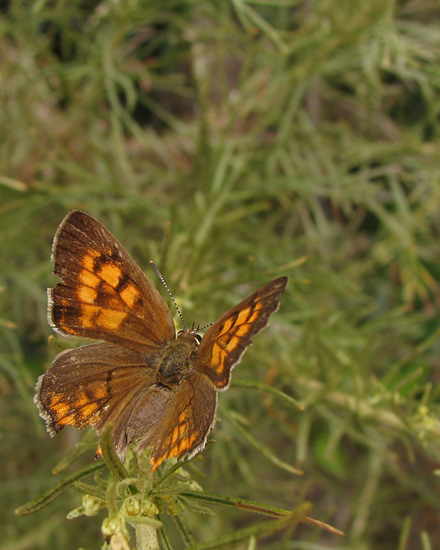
[0,0,440,550]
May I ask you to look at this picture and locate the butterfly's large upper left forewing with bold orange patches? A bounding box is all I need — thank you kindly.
[48,210,175,352]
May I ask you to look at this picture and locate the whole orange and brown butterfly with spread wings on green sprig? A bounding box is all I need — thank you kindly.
[34,211,287,469]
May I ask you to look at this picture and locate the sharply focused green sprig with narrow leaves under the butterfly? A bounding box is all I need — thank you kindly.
[15,424,318,550]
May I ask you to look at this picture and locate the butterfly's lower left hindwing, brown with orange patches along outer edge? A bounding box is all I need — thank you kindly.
[34,343,156,453]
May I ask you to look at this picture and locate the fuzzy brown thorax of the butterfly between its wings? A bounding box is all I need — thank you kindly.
[157,330,200,387]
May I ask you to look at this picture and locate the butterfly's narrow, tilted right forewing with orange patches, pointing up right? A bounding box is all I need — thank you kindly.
[194,277,287,391]
